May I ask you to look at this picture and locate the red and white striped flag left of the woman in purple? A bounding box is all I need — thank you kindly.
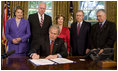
[2,1,10,51]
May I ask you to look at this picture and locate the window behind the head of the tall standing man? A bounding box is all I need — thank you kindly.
[28,1,52,16]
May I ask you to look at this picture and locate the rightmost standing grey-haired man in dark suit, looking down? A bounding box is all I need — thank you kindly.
[87,9,117,54]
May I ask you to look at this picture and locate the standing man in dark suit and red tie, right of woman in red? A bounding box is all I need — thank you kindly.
[70,10,91,56]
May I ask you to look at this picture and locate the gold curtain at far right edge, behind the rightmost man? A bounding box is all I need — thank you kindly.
[106,1,117,61]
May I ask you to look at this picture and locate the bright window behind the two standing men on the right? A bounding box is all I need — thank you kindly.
[80,1,105,21]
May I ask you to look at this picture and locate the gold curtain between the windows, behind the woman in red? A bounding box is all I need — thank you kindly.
[52,1,78,27]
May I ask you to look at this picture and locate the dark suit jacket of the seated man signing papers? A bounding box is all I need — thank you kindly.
[29,38,67,57]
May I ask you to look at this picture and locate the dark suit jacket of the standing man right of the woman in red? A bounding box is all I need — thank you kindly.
[70,21,91,56]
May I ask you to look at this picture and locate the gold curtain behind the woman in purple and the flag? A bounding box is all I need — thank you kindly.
[1,1,28,32]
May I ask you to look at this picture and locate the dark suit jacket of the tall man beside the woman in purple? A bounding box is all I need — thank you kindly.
[28,13,52,48]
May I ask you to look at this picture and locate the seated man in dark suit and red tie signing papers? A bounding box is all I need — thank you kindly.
[29,25,67,59]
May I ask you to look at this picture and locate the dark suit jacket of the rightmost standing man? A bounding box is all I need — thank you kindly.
[91,20,117,49]
